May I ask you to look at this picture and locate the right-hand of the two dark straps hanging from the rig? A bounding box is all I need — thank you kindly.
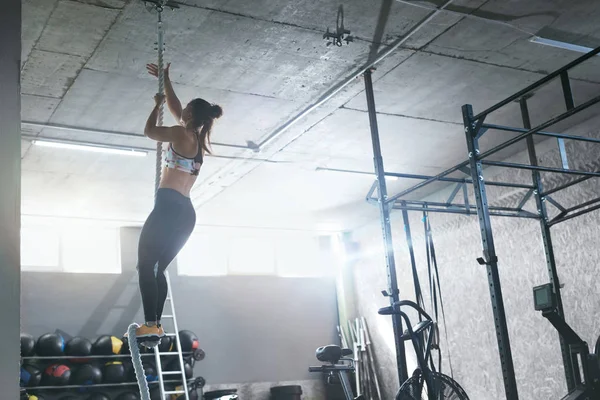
[423,211,454,378]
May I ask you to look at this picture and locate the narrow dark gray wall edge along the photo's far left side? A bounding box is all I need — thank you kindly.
[0,0,21,399]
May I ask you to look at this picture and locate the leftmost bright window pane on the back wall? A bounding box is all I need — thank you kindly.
[21,226,61,272]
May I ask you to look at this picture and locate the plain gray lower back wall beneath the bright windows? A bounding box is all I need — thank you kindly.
[22,229,338,398]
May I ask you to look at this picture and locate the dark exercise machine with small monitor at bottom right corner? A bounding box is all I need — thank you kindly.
[533,284,600,400]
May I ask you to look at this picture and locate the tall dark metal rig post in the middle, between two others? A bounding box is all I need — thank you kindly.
[462,104,519,400]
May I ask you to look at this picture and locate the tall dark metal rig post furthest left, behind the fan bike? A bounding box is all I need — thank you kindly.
[364,69,408,384]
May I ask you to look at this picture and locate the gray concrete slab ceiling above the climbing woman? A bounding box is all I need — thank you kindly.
[22,0,600,229]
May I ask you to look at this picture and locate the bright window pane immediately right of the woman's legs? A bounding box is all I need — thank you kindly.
[177,233,229,276]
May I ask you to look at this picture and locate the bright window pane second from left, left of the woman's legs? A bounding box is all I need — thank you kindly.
[61,228,121,274]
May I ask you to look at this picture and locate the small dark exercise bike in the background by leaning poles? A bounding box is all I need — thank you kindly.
[308,345,365,400]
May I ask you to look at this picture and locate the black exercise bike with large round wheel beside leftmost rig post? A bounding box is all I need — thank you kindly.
[379,300,469,400]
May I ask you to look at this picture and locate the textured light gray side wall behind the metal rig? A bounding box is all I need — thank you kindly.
[354,114,600,400]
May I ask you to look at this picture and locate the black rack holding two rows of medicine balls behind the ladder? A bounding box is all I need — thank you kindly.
[20,330,206,398]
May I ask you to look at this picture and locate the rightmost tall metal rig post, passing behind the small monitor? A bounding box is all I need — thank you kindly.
[519,97,575,391]
